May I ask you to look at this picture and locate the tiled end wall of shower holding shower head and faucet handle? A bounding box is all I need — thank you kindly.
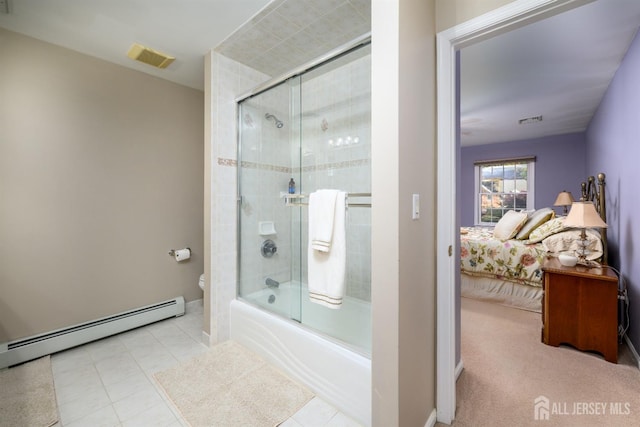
[239,83,297,295]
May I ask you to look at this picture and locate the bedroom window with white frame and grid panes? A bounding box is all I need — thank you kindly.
[475,157,535,225]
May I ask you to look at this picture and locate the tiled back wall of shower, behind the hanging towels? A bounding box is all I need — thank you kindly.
[294,46,371,301]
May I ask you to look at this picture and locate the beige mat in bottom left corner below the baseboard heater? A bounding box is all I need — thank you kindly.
[0,356,58,427]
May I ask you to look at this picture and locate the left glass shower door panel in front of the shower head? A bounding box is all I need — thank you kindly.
[238,78,302,320]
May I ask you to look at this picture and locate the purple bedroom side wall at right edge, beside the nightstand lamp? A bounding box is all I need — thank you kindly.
[586,29,640,350]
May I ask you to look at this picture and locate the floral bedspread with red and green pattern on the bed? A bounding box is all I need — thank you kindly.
[460,227,546,287]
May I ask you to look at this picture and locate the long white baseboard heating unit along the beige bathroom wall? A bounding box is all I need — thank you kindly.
[0,297,184,369]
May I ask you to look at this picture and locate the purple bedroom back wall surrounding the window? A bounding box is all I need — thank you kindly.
[460,133,584,227]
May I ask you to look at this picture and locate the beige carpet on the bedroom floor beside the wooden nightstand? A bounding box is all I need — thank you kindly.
[454,298,640,427]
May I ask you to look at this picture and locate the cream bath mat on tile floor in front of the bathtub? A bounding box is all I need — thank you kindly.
[154,341,313,427]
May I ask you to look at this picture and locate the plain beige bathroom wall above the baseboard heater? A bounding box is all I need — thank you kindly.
[0,30,204,342]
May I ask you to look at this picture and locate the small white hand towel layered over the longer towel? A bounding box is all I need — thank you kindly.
[309,190,338,252]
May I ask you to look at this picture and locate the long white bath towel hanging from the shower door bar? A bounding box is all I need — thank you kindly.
[307,190,347,309]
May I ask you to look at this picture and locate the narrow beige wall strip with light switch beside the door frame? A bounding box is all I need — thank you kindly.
[398,0,436,426]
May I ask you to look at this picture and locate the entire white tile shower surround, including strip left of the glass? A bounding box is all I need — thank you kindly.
[209,44,371,342]
